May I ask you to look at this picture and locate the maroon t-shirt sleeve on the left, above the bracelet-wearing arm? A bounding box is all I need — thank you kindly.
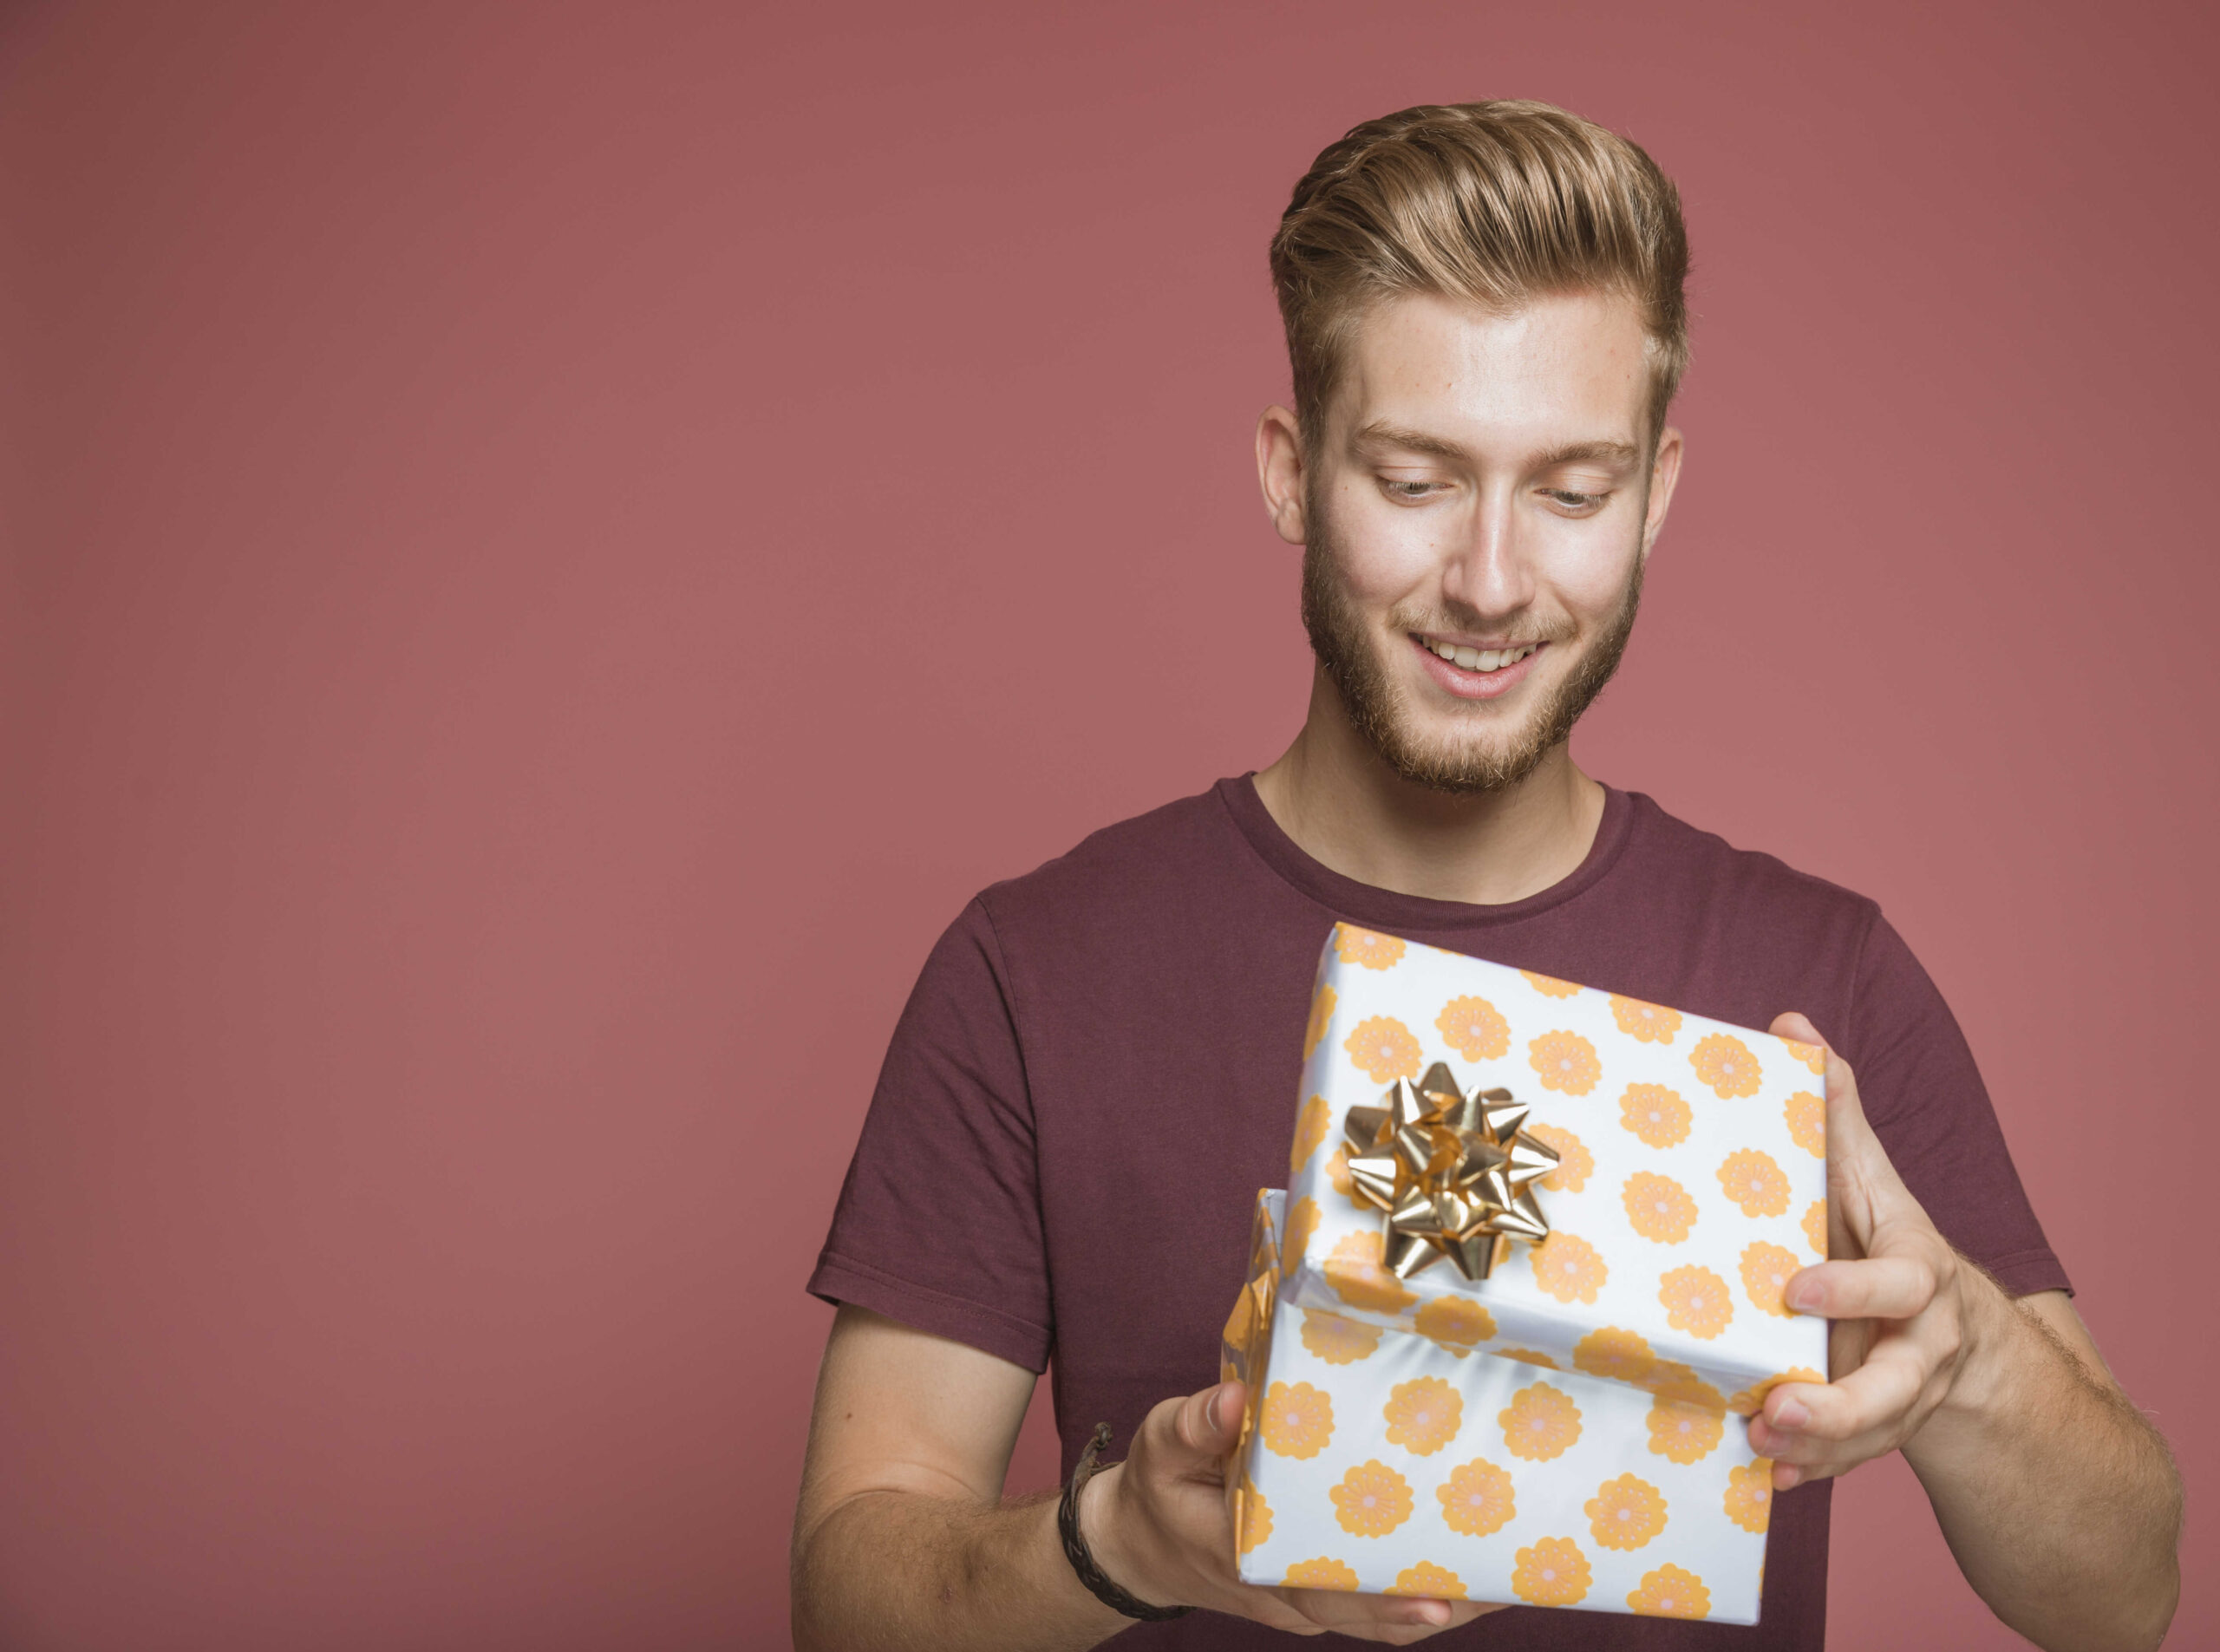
[808,902,1052,1372]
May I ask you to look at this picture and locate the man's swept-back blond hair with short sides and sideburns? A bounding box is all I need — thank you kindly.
[1272,100,1688,444]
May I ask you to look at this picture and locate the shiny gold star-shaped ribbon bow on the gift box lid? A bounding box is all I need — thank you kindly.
[1343,1061,1557,1279]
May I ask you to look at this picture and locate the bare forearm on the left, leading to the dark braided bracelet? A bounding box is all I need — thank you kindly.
[794,1492,1127,1652]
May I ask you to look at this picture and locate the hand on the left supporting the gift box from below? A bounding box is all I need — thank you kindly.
[1079,1383,1501,1645]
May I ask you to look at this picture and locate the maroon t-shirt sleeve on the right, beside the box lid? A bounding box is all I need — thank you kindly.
[1843,915,2071,1296]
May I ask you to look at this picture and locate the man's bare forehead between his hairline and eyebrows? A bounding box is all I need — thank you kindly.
[1335,293,1649,451]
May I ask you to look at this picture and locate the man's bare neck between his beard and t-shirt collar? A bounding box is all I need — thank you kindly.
[1257,670,1603,906]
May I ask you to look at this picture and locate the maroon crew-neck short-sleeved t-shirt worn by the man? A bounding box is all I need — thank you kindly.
[810,777,2067,1649]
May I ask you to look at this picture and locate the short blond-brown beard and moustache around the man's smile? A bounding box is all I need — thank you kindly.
[1303,502,1642,797]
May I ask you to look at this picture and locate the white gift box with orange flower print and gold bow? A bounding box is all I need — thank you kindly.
[1224,924,1827,1623]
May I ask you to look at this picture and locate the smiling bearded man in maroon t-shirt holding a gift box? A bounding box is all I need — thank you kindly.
[794,102,2180,1648]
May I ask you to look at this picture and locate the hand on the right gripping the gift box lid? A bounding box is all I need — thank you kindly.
[1749,1015,2005,1492]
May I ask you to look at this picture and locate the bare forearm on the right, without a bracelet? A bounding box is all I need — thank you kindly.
[1904,1281,2182,1649]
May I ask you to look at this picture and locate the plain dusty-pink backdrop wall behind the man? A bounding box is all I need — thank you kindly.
[0,3,2220,1652]
